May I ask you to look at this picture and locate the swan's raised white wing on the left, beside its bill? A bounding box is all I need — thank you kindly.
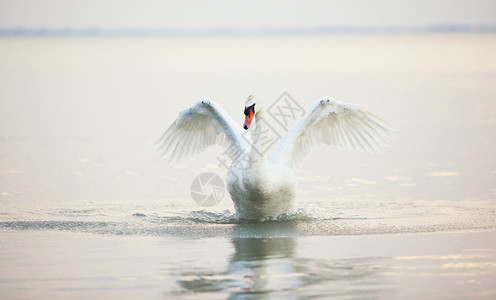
[157,97,246,161]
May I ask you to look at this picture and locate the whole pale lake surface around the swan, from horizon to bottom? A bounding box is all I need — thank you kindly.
[0,34,496,299]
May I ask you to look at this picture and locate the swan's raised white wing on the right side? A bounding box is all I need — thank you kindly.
[274,97,395,168]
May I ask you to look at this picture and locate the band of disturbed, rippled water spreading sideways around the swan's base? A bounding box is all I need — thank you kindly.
[0,199,496,239]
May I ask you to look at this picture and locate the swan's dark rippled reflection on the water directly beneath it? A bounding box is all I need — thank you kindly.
[179,222,304,298]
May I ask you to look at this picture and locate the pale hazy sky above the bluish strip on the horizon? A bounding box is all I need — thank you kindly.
[0,0,496,30]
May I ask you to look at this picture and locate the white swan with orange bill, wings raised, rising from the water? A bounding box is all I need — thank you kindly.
[158,95,395,219]
